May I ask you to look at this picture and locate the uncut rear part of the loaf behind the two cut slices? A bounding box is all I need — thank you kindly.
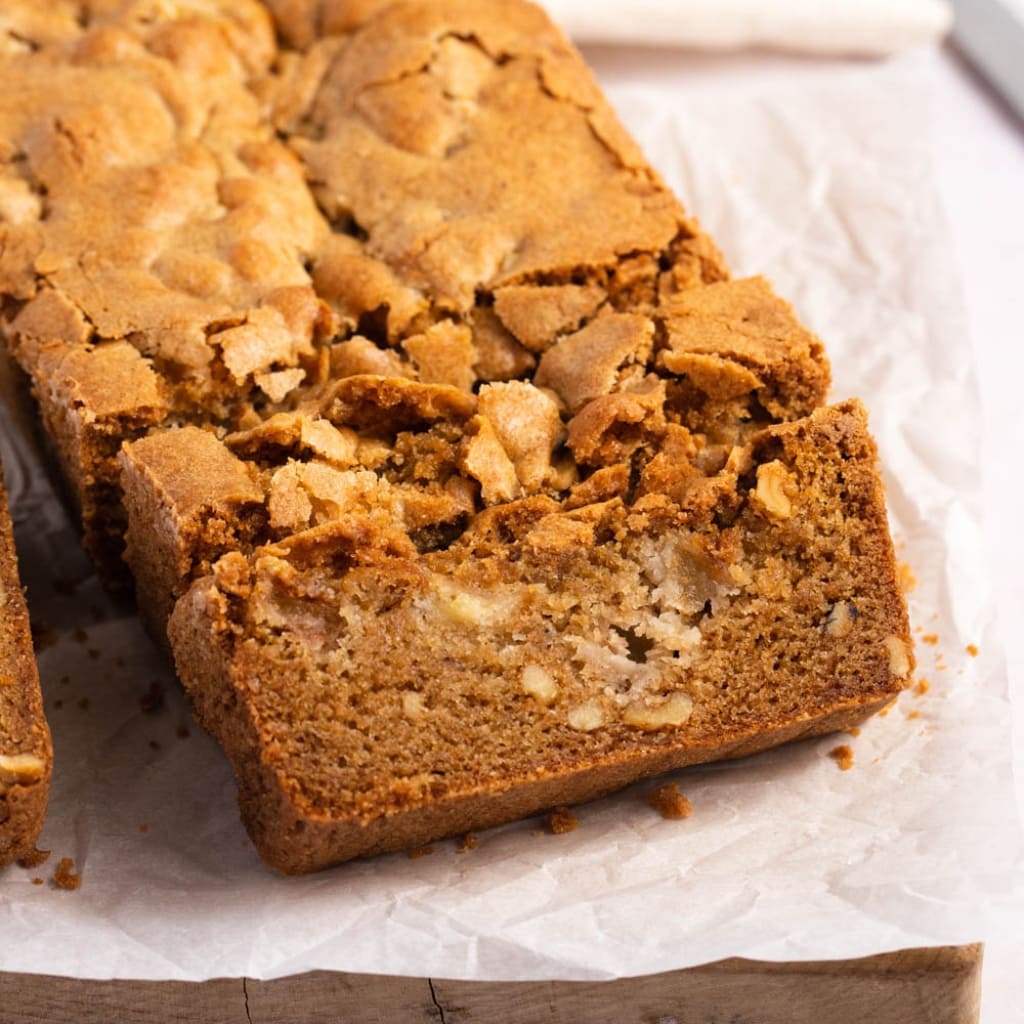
[0,0,727,580]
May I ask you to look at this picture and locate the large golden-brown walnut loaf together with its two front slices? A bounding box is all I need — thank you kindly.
[0,0,911,872]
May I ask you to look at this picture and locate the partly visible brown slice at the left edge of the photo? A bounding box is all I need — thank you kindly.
[0,471,53,867]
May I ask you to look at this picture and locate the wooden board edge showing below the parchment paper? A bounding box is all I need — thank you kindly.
[0,945,982,1024]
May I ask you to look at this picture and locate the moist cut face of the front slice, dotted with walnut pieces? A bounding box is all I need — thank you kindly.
[197,403,905,815]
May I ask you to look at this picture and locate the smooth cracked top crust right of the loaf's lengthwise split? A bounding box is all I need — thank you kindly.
[282,0,727,315]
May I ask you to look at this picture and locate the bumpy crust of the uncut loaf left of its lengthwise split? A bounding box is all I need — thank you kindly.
[0,0,326,583]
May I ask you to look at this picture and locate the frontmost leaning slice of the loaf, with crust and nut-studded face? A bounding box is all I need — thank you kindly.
[159,403,912,872]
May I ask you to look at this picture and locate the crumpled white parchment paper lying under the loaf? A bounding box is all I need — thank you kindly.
[0,51,1024,980]
